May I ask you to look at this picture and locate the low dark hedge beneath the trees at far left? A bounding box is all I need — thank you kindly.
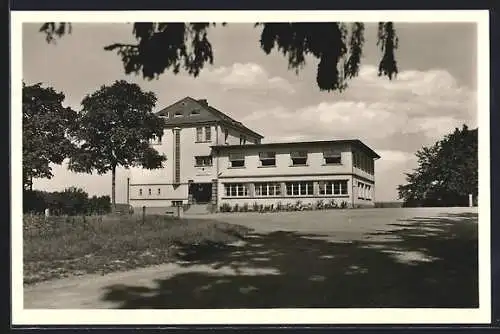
[23,187,111,215]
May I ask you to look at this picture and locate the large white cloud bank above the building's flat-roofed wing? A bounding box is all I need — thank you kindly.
[243,66,477,145]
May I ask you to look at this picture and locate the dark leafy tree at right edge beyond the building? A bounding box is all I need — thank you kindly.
[398,125,478,206]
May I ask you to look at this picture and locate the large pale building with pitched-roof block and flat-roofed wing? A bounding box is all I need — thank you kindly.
[127,97,380,213]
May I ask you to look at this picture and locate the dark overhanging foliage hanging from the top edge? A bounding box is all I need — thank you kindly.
[40,22,398,91]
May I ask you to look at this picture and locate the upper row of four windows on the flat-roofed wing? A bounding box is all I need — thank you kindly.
[229,150,342,168]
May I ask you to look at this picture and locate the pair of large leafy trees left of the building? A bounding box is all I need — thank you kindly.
[23,80,165,208]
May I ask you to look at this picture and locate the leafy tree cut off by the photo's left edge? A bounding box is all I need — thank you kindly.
[23,82,76,190]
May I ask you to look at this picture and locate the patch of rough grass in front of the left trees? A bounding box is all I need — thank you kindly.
[23,215,249,284]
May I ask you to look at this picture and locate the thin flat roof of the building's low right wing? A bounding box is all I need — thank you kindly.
[212,139,380,159]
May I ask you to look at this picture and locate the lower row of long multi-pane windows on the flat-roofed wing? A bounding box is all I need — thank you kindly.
[224,180,348,197]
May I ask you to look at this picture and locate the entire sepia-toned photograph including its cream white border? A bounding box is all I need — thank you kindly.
[11,11,491,324]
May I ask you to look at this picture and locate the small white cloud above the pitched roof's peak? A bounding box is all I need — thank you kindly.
[200,63,295,94]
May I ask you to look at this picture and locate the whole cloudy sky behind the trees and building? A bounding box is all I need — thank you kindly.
[22,23,477,202]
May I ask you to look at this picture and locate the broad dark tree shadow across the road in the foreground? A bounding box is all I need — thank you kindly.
[103,214,478,309]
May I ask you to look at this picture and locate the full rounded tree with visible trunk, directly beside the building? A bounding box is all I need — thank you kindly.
[69,80,166,210]
